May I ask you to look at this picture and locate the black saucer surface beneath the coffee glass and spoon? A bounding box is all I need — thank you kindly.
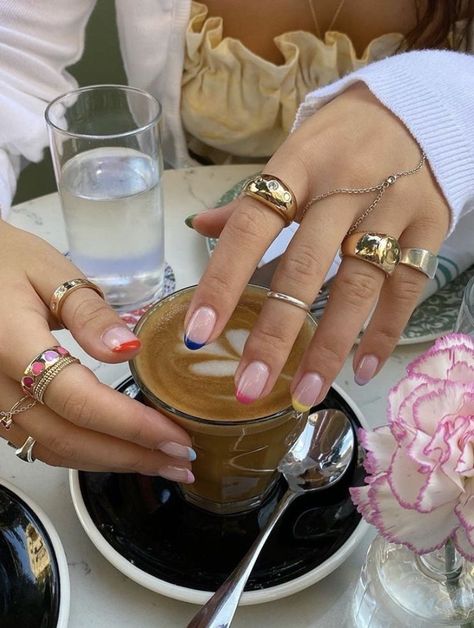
[79,378,365,591]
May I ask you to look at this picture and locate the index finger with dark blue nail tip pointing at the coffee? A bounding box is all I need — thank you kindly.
[185,149,308,348]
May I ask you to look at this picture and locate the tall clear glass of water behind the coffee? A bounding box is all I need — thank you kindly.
[45,85,164,312]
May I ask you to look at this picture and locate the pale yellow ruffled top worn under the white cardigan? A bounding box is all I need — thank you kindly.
[181,2,403,163]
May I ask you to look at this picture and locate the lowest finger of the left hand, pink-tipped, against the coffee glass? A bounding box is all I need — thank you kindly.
[0,376,192,482]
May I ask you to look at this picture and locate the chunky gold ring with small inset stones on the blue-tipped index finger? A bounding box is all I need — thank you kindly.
[242,174,297,225]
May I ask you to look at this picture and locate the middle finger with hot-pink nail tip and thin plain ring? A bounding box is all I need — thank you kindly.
[231,199,354,403]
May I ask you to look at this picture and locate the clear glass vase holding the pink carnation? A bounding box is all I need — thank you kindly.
[349,536,474,628]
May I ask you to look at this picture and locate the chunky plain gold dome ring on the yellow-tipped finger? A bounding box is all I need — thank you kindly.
[341,231,401,275]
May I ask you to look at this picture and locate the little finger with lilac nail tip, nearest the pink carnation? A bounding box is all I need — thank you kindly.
[353,224,442,386]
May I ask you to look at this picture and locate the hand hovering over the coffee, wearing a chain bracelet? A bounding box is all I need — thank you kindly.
[185,83,449,409]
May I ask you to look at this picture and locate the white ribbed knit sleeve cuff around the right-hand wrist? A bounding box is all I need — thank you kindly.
[294,50,474,237]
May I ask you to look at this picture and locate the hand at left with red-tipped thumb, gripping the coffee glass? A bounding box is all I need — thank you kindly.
[0,221,193,482]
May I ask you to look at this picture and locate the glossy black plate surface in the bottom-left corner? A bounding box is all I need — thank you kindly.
[0,484,60,628]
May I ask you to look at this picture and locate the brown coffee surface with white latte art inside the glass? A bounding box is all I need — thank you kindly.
[135,288,312,420]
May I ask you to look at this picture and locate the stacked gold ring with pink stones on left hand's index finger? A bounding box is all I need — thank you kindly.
[20,345,79,403]
